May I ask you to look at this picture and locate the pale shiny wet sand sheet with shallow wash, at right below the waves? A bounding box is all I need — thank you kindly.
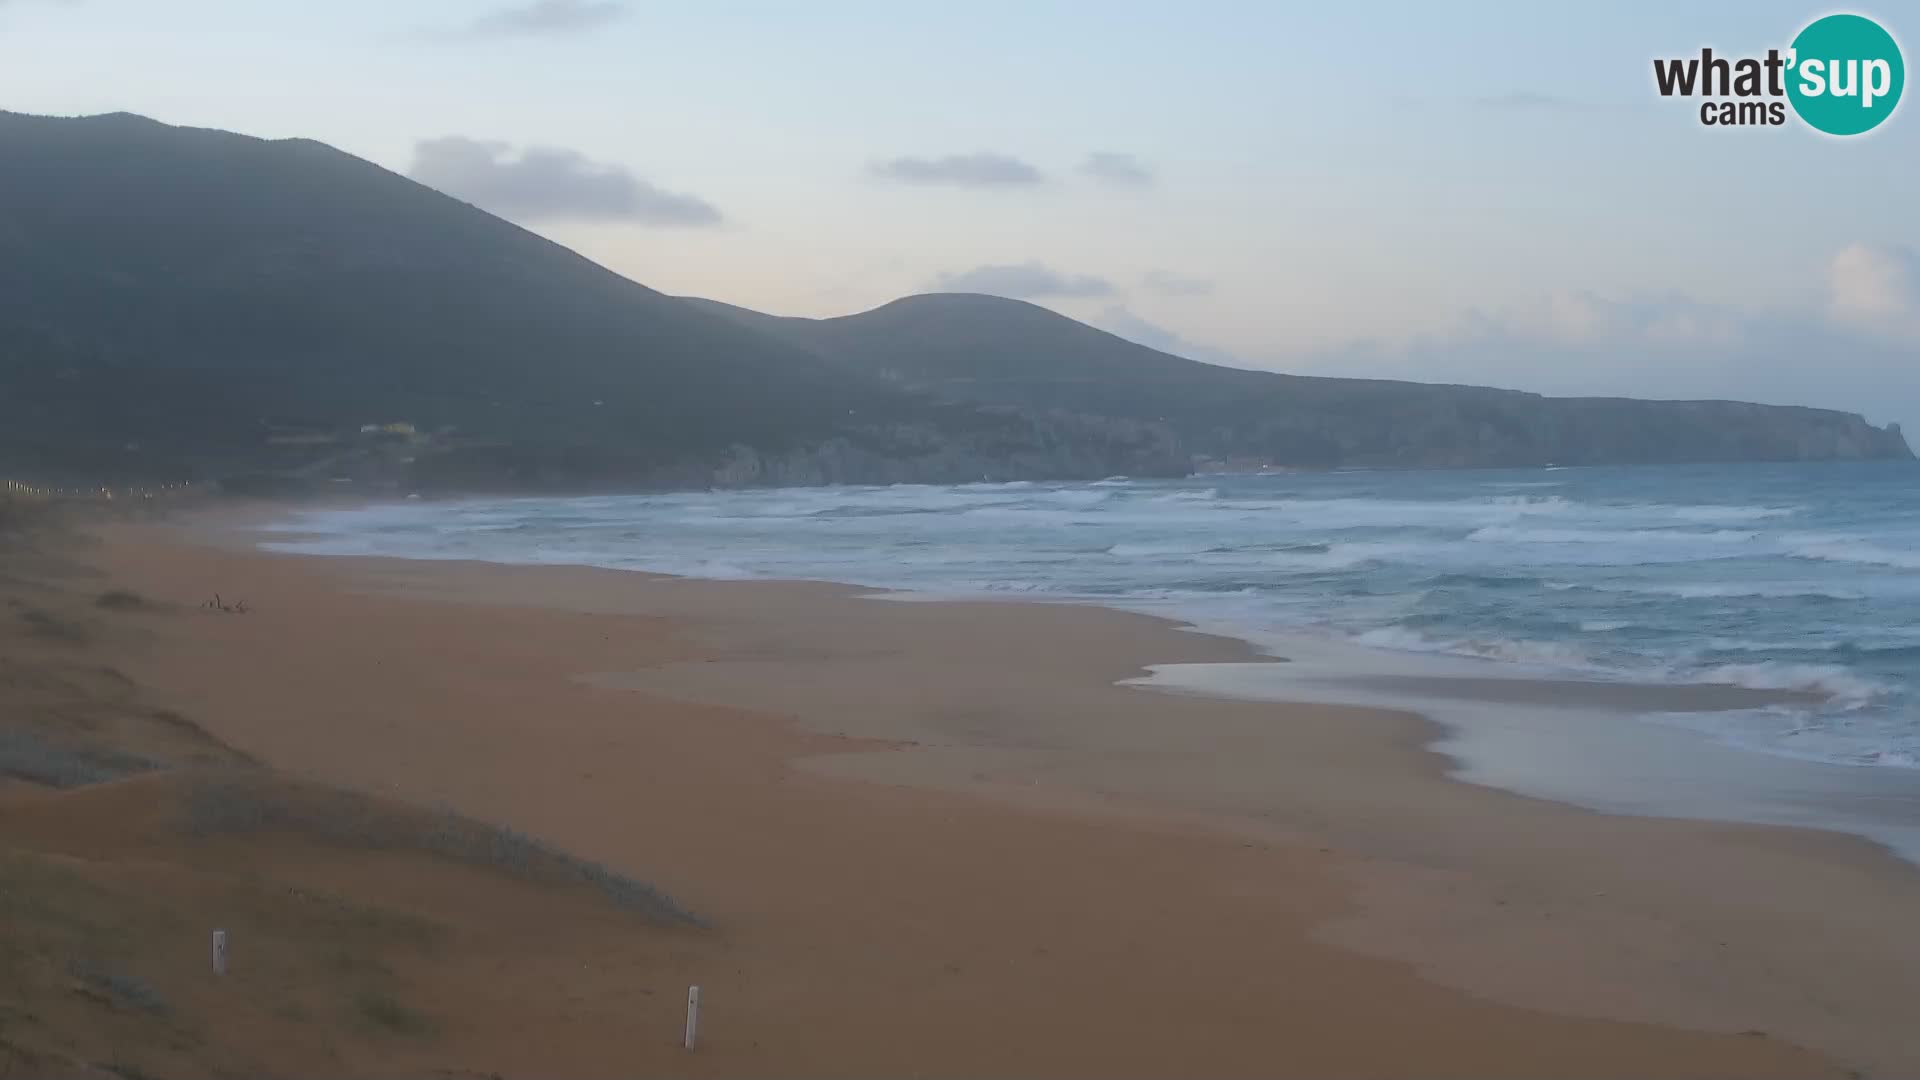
[1127,634,1920,865]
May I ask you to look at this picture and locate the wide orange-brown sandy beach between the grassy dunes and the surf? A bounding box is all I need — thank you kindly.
[0,507,1920,1076]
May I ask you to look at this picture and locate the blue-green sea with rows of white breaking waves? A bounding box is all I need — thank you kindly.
[267,461,1920,849]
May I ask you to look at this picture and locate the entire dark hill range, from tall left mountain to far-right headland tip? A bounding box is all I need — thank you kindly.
[0,113,1908,490]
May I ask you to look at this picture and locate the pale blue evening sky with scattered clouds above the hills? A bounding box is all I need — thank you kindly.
[0,0,1920,430]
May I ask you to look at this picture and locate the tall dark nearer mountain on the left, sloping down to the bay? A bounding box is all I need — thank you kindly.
[0,113,1185,486]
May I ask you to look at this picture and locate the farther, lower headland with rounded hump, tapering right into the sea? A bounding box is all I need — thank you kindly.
[689,294,1912,467]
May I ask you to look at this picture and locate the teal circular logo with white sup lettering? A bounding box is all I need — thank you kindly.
[1788,15,1907,135]
